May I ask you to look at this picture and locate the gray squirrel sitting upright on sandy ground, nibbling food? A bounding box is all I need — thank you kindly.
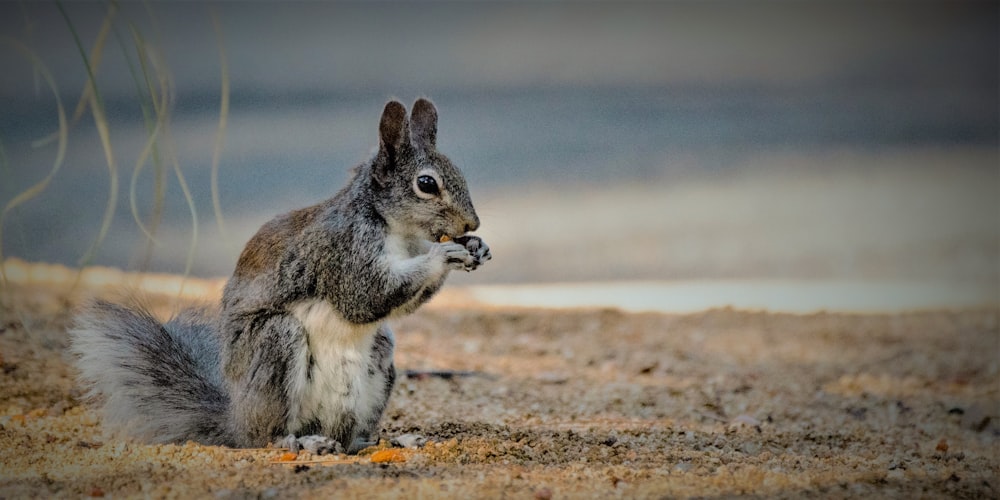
[70,99,491,454]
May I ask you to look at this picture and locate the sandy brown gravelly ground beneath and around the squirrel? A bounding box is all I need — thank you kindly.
[0,276,1000,499]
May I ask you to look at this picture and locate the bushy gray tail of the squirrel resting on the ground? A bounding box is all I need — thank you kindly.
[70,301,232,445]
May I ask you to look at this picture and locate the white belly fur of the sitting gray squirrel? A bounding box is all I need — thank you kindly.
[289,300,385,436]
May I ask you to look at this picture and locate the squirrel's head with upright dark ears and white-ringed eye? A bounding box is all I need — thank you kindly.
[369,99,479,241]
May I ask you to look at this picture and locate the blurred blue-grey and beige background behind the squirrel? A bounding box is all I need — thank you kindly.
[0,1,1000,300]
